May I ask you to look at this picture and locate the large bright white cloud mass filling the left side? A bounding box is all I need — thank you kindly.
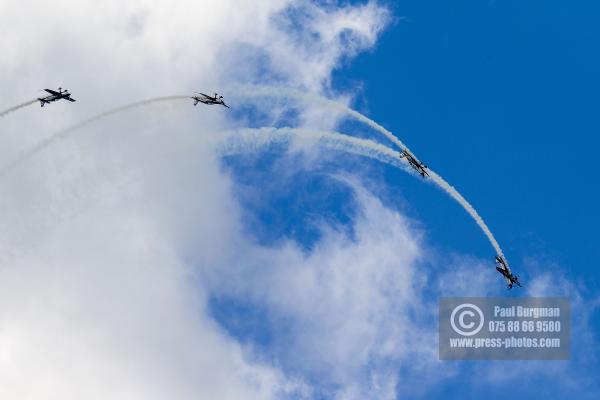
[0,0,398,399]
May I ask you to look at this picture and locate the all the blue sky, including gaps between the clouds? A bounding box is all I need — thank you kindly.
[214,1,600,399]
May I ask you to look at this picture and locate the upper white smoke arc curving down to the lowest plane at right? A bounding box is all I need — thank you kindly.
[234,86,508,264]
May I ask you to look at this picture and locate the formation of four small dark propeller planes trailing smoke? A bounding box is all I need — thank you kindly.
[32,87,521,289]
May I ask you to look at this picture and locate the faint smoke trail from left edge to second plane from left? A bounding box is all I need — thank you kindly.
[0,95,190,179]
